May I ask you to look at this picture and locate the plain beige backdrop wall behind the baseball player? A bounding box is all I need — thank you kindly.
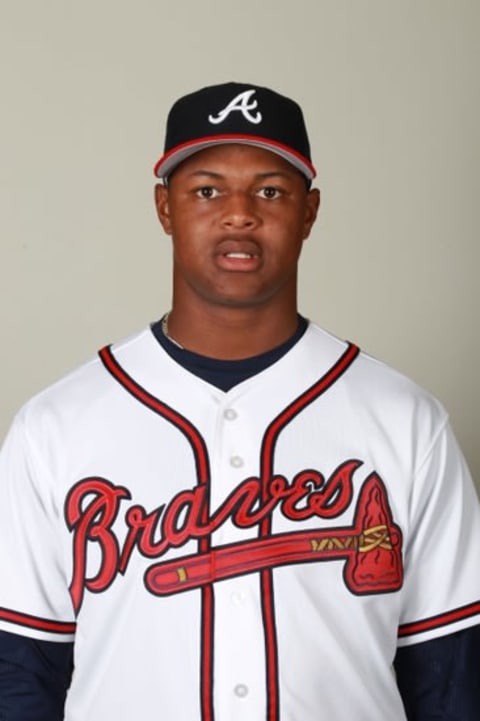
[0,0,480,490]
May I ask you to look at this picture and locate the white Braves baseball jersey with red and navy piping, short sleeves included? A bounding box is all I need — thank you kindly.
[0,324,480,721]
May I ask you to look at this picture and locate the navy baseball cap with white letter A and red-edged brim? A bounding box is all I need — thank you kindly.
[154,83,316,181]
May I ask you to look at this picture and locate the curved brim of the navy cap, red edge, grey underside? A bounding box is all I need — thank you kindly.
[154,135,317,180]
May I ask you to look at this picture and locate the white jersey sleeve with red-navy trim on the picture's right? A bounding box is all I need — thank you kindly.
[398,419,480,646]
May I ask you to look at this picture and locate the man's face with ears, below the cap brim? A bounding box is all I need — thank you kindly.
[156,144,319,307]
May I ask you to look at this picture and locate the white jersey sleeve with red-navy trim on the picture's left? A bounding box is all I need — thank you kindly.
[0,413,75,641]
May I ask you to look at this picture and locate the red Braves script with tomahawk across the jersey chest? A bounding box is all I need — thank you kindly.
[65,460,402,610]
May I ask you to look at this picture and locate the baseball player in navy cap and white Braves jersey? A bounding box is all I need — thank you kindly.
[0,83,480,721]
